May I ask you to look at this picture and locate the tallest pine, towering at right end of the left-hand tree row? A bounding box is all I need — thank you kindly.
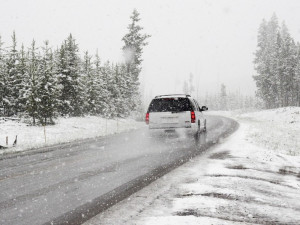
[122,9,150,111]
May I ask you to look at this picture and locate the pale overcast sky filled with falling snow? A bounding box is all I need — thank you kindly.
[0,0,300,101]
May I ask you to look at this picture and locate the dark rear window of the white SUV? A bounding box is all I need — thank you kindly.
[148,98,192,112]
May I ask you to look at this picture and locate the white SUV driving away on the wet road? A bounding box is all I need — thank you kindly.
[146,94,208,132]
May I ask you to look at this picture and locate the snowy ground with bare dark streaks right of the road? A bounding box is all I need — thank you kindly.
[86,107,300,225]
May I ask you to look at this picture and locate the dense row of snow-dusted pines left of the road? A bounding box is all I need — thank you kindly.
[0,10,150,125]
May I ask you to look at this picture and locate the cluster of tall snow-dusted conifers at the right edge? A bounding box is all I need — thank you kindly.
[254,14,300,109]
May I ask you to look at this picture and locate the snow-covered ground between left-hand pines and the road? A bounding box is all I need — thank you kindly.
[0,116,145,154]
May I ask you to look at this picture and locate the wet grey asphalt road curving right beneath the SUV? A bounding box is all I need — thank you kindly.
[0,116,238,225]
